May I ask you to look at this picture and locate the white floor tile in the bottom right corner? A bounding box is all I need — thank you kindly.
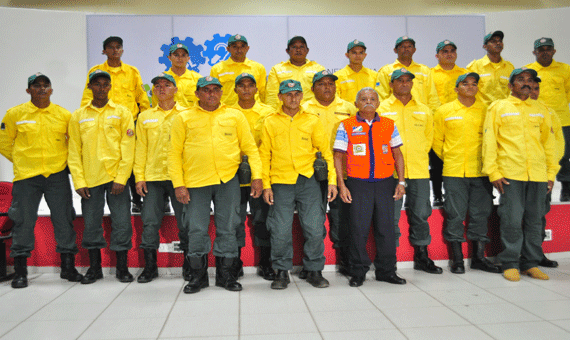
[479,321,570,340]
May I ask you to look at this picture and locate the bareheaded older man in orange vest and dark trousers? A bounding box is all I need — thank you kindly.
[334,87,406,287]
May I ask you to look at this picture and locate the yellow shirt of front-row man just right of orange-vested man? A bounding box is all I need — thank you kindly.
[376,94,433,179]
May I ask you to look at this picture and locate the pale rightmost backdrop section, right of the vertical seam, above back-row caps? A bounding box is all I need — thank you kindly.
[408,15,485,67]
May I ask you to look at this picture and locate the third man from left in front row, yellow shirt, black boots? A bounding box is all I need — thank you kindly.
[133,73,186,283]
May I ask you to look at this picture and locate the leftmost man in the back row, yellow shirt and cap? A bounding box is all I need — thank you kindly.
[81,36,150,213]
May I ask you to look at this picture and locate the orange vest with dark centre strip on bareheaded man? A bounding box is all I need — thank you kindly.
[342,116,394,179]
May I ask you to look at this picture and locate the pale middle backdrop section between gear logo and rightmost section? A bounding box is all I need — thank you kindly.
[289,16,406,72]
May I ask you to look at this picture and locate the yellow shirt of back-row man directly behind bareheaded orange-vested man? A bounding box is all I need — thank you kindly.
[334,65,378,103]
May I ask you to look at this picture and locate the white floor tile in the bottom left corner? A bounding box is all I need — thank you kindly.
[2,320,92,340]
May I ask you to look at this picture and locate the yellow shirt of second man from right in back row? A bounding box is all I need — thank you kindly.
[467,55,515,106]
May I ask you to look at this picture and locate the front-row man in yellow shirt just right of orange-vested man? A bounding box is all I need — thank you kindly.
[377,68,443,274]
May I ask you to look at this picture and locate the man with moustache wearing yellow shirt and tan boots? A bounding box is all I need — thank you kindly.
[482,68,560,281]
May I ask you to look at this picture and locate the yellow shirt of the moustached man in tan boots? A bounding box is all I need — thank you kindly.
[483,96,560,182]
